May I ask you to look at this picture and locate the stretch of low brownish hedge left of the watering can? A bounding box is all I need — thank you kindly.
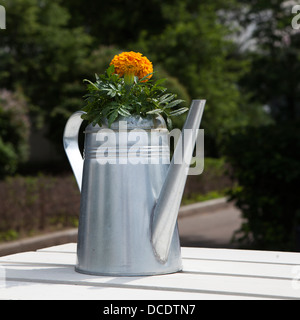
[0,175,80,242]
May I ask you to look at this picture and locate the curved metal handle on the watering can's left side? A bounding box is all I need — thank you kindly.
[63,111,85,191]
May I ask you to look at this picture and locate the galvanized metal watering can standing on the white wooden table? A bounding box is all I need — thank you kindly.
[63,100,205,276]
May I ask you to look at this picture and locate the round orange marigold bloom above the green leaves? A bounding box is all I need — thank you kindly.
[110,51,153,84]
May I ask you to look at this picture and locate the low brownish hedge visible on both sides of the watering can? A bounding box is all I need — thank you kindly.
[0,159,230,242]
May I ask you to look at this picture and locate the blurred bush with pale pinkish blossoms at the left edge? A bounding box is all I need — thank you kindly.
[0,89,30,178]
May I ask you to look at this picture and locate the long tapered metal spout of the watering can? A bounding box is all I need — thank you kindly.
[151,100,206,263]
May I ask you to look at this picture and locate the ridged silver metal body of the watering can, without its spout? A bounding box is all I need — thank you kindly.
[65,113,182,275]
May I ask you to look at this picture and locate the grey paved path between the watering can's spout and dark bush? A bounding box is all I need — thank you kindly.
[178,206,242,248]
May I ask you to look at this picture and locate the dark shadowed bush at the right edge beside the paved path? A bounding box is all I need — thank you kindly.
[225,122,300,250]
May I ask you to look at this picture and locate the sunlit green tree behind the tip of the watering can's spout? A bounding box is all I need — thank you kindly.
[136,0,253,155]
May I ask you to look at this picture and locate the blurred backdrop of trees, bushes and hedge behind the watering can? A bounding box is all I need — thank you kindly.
[0,0,300,251]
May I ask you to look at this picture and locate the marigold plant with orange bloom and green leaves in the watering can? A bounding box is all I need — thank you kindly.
[82,51,188,128]
